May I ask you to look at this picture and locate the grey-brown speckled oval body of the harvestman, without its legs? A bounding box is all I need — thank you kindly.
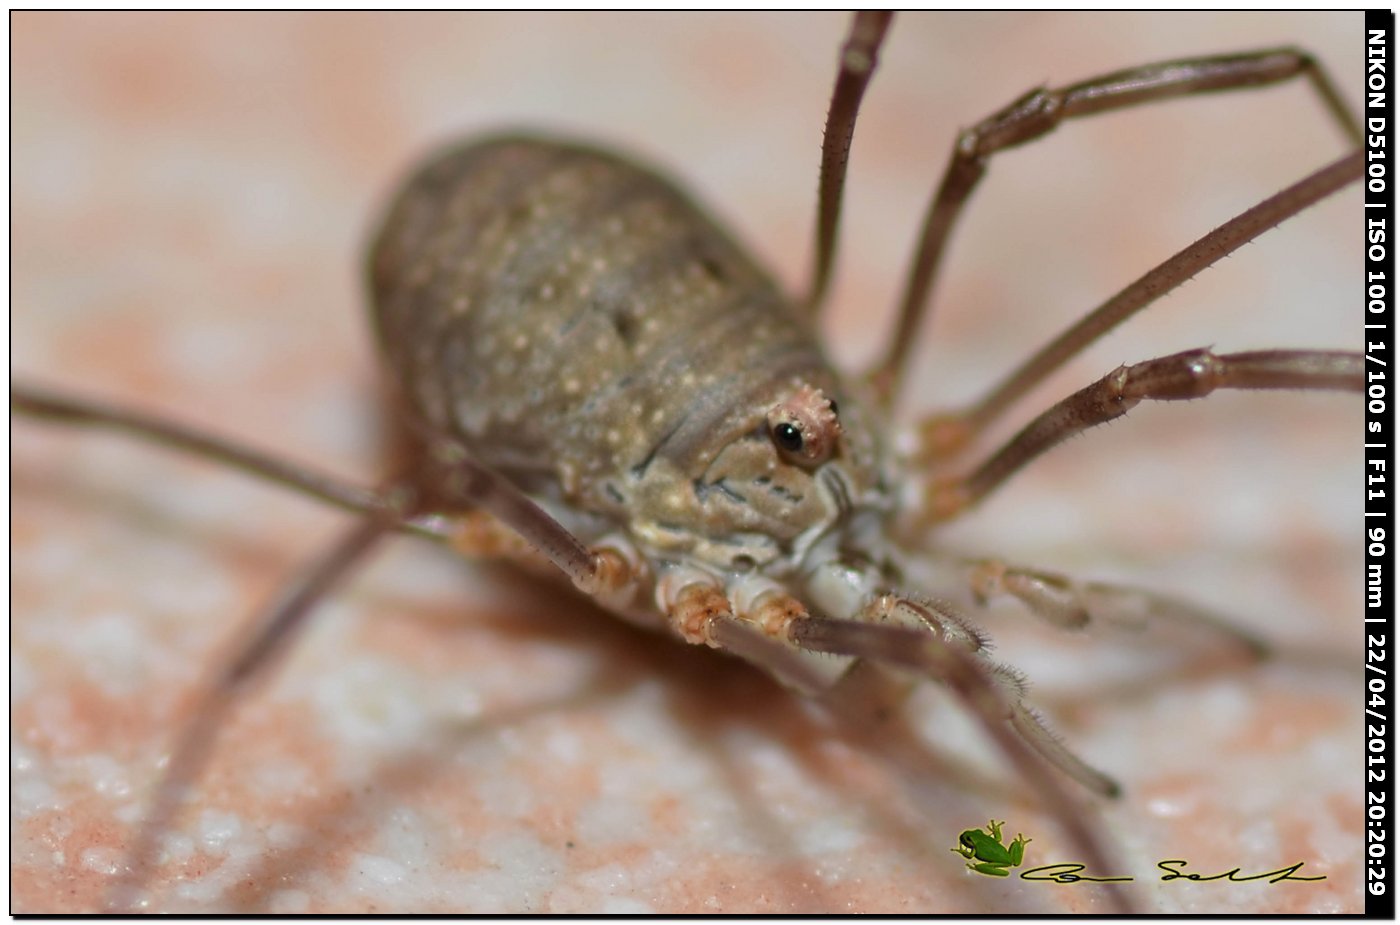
[370,137,888,572]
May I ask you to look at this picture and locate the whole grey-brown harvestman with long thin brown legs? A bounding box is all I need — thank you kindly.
[11,13,1362,907]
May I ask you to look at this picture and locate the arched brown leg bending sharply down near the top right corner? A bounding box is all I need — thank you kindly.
[871,48,1361,403]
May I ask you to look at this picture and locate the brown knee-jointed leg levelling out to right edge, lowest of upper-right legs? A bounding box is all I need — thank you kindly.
[923,350,1365,521]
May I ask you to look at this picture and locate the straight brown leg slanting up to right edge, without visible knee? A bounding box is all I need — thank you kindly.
[920,151,1364,456]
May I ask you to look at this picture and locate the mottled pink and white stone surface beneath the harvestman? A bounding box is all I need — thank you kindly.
[11,14,1364,912]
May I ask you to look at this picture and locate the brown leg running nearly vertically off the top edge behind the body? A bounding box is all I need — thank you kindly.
[804,10,895,315]
